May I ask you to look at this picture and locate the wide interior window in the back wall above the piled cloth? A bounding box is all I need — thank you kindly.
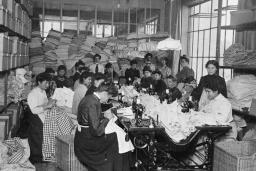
[33,0,161,37]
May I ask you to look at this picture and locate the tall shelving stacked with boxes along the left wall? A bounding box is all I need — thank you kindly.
[0,0,32,109]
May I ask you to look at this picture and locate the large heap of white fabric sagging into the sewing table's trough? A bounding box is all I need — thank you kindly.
[139,94,231,142]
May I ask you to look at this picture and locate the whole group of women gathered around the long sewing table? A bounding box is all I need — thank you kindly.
[24,51,236,171]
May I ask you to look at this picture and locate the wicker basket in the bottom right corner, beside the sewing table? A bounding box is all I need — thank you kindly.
[213,141,256,171]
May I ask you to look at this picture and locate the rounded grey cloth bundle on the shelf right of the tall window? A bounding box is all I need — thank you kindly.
[224,43,256,66]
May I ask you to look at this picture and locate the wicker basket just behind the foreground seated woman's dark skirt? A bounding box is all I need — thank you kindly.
[56,135,87,171]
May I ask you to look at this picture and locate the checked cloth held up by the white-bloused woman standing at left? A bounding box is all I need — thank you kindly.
[42,107,74,162]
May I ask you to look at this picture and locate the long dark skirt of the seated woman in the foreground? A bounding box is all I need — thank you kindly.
[74,128,130,171]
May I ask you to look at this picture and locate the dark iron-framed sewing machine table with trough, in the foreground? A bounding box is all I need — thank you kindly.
[119,117,231,170]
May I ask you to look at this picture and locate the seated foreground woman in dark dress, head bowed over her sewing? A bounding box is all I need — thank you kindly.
[74,84,129,171]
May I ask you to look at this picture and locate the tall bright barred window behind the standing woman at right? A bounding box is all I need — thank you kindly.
[188,0,238,81]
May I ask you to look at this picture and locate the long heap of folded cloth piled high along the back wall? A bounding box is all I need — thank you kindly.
[30,30,168,73]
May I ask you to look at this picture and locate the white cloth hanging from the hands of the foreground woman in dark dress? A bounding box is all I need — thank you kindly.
[105,116,134,154]
